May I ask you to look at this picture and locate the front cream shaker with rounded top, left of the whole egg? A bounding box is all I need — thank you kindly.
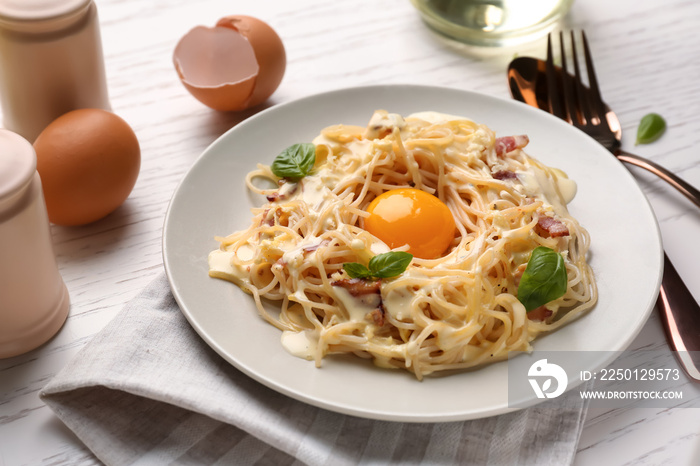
[0,129,70,358]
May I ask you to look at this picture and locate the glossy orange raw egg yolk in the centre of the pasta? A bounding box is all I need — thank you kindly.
[365,188,455,259]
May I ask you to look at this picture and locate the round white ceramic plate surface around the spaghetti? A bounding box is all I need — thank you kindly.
[163,85,662,422]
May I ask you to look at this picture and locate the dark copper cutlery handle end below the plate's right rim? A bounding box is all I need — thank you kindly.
[657,253,700,381]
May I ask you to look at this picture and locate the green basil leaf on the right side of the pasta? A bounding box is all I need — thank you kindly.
[518,246,568,312]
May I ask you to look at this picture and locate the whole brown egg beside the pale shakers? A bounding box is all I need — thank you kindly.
[34,109,141,225]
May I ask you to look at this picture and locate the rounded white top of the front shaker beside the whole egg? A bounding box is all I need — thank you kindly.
[0,129,36,200]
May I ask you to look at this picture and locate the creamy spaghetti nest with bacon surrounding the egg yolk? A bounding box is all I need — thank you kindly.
[209,110,597,379]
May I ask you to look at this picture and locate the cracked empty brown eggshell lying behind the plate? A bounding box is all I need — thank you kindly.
[173,15,287,111]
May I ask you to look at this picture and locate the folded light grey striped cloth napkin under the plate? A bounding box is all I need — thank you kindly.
[41,275,587,465]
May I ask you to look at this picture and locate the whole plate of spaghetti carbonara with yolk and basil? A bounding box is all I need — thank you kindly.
[163,85,662,422]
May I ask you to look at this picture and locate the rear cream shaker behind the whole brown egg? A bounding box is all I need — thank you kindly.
[0,0,111,142]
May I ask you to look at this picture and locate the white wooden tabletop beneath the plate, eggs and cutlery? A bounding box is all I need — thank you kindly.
[0,0,700,465]
